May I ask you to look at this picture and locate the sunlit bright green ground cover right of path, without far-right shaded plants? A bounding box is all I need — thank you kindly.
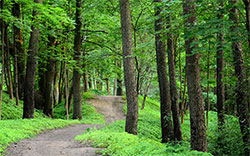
[76,96,211,156]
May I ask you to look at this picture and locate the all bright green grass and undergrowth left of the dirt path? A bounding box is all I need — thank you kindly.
[0,93,105,156]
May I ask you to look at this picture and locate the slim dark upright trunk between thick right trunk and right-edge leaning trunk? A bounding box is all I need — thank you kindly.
[216,0,225,129]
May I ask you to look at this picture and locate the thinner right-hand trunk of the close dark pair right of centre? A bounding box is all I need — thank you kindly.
[167,11,182,141]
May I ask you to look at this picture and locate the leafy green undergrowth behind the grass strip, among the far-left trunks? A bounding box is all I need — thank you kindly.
[1,93,44,120]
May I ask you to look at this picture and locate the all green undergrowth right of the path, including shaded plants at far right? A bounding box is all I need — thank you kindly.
[76,97,244,156]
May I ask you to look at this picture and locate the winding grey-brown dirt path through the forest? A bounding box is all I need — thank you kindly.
[5,96,125,156]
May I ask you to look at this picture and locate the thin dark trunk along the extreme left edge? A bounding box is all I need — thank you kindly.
[0,0,5,120]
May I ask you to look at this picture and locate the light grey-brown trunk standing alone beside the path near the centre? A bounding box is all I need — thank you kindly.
[120,0,138,135]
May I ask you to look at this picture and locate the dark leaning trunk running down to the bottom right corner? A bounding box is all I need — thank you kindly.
[229,0,250,156]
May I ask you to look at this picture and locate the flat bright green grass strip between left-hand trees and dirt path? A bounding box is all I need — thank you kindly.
[0,118,80,156]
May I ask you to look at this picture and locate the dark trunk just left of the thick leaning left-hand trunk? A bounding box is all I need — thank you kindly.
[12,1,25,99]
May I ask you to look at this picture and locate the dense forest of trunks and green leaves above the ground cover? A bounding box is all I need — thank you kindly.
[0,0,250,155]
